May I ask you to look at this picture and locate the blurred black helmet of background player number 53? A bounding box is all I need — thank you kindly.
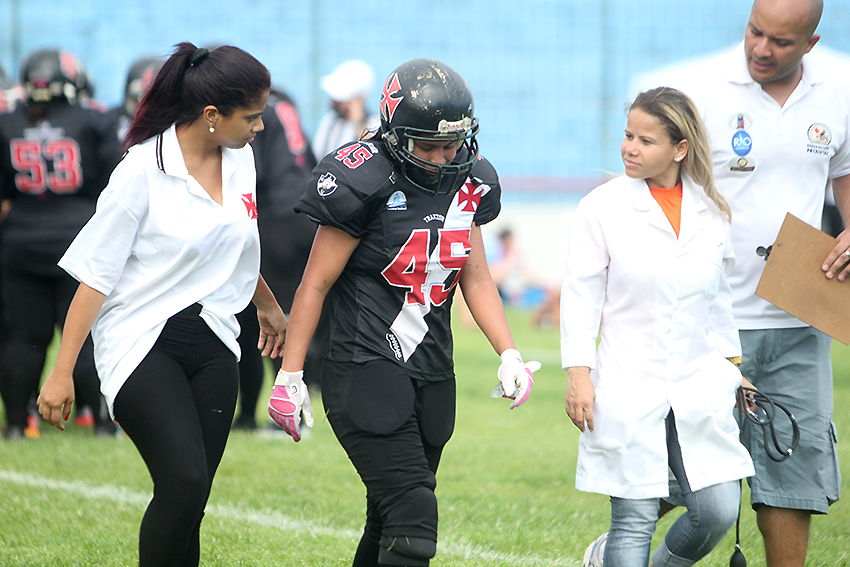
[21,49,88,104]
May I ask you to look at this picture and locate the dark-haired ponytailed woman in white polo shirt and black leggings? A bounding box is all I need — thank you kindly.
[39,43,286,567]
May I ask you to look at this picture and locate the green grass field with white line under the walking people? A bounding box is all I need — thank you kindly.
[0,311,850,567]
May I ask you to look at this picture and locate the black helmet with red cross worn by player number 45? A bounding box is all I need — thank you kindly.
[381,59,478,194]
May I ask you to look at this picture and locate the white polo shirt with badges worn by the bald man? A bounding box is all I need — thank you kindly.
[669,43,850,329]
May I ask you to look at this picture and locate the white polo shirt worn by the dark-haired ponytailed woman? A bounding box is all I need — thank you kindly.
[59,126,260,418]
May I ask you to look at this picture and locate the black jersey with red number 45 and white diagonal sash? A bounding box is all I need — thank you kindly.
[295,140,501,380]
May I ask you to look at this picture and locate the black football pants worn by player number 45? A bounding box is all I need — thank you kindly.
[322,360,455,567]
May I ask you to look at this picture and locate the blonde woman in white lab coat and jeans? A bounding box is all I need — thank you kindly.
[561,87,753,567]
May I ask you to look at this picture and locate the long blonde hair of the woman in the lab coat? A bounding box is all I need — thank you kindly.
[629,87,732,221]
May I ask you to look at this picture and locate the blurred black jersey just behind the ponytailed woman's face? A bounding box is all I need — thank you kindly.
[251,91,316,216]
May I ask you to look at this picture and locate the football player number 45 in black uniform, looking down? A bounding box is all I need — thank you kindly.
[269,59,539,567]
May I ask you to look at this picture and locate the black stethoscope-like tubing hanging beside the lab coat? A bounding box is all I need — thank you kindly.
[729,386,800,567]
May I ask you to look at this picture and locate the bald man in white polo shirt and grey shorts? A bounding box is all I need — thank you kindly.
[672,0,850,567]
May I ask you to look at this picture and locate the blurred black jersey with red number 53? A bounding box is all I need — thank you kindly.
[0,102,111,247]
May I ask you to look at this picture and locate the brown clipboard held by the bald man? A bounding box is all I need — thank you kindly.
[756,213,850,345]
